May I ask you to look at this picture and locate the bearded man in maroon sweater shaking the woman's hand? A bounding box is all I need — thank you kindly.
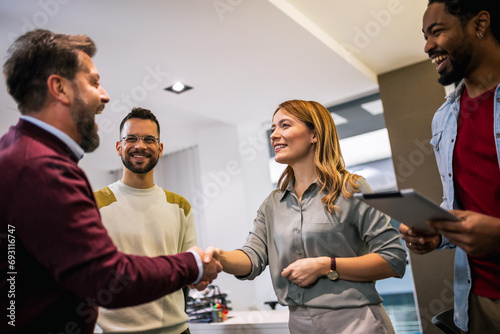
[0,30,222,333]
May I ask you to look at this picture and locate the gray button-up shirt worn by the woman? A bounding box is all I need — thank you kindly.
[239,178,406,309]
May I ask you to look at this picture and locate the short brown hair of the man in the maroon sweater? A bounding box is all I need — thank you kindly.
[3,29,97,114]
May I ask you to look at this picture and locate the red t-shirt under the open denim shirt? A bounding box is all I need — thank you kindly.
[453,89,500,299]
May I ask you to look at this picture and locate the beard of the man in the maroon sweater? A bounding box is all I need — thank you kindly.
[71,87,100,153]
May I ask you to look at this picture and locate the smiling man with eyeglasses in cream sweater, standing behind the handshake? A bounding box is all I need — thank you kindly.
[95,108,197,334]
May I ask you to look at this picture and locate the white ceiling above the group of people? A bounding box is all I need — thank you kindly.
[0,0,427,168]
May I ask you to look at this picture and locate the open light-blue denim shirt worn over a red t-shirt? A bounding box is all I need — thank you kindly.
[431,81,500,331]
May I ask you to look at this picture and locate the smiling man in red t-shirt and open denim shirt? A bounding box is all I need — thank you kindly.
[400,0,500,333]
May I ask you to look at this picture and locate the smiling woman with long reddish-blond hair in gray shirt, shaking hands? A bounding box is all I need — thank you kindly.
[211,100,406,334]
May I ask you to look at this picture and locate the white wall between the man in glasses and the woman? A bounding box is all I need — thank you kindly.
[193,125,284,310]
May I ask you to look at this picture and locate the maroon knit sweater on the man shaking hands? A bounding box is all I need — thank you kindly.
[0,119,199,334]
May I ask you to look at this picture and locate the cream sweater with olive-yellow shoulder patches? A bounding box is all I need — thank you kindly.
[94,181,197,334]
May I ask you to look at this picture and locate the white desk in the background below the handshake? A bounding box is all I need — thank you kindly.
[189,310,290,334]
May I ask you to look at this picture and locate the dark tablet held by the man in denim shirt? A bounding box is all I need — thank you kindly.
[354,189,460,231]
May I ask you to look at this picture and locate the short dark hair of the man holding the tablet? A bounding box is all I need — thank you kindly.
[429,0,500,43]
